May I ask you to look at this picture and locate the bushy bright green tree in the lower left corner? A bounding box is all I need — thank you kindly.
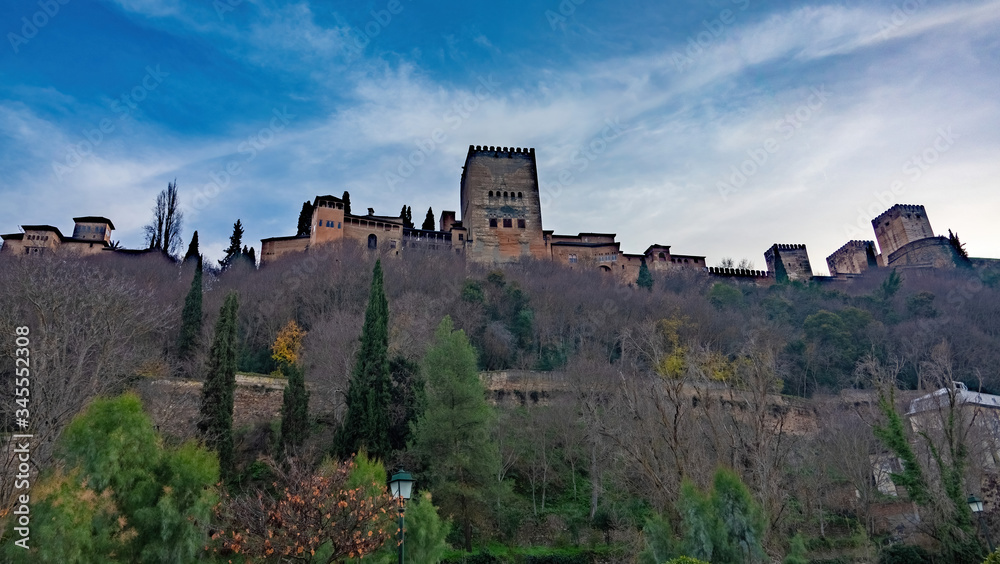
[9,394,219,563]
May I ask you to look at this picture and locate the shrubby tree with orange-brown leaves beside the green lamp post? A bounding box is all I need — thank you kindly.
[216,460,396,564]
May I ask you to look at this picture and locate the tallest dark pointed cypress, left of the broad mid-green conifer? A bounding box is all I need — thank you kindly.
[333,261,392,460]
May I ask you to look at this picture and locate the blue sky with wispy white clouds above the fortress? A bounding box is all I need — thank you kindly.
[0,0,1000,272]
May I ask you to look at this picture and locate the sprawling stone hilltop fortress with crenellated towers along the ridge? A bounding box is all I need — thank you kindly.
[0,145,992,278]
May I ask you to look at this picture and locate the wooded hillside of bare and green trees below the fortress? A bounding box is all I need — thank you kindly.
[0,243,1000,564]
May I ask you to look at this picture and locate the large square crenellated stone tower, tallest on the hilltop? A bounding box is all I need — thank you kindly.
[461,145,547,263]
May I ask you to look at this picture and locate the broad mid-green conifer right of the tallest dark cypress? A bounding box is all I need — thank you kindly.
[412,317,498,551]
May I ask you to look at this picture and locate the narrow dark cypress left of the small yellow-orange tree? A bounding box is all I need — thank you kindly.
[198,292,240,479]
